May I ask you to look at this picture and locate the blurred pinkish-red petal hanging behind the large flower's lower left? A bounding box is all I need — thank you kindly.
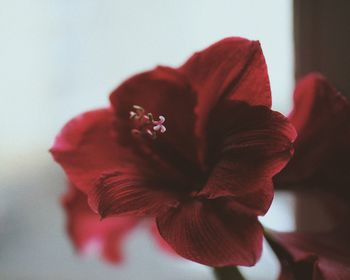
[63,183,139,263]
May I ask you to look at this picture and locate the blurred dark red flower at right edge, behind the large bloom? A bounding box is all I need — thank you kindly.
[267,74,350,280]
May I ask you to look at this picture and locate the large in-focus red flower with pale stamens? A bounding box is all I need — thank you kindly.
[51,38,295,266]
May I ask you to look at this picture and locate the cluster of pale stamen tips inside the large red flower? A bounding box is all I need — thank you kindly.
[130,105,166,139]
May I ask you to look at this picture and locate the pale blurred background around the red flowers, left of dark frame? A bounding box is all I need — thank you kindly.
[0,0,294,280]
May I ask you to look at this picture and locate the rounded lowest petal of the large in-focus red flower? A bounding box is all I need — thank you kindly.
[157,200,262,267]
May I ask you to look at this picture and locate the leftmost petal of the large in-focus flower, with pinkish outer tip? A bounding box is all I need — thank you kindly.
[51,109,182,217]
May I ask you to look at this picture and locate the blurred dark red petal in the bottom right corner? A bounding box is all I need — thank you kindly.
[268,228,350,280]
